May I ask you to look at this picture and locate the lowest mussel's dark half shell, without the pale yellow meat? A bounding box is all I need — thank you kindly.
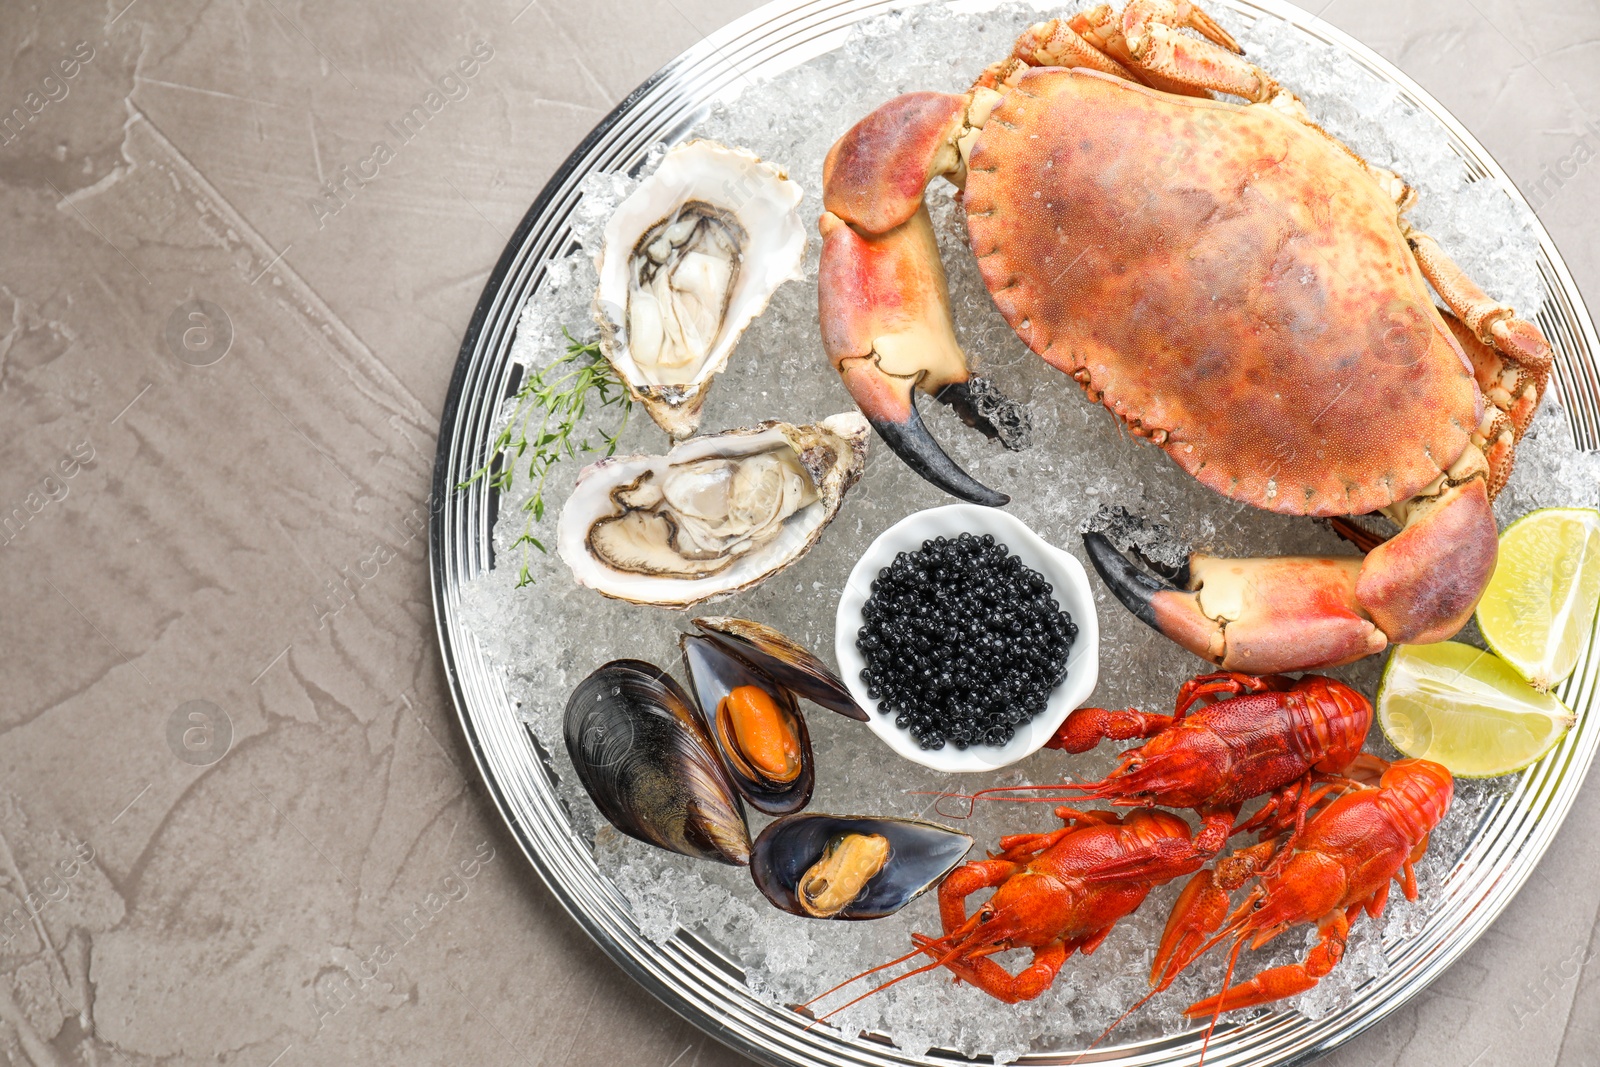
[750,813,973,918]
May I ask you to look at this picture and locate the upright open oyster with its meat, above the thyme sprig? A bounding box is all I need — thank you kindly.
[595,141,806,440]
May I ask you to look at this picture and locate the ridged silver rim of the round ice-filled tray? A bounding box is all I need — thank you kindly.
[429,0,1600,1067]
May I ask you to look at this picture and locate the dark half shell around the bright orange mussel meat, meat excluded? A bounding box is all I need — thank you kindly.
[678,633,816,816]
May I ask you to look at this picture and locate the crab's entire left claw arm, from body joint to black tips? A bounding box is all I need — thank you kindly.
[818,88,1026,507]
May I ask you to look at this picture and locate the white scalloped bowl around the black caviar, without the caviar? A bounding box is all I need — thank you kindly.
[834,504,1099,773]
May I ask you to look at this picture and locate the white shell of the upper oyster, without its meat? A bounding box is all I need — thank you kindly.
[594,141,806,440]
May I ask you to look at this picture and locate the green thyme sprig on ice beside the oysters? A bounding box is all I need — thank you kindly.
[458,326,634,589]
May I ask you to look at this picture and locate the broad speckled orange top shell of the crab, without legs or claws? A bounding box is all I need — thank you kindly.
[963,69,1483,515]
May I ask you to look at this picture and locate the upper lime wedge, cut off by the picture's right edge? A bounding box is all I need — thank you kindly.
[1478,507,1600,689]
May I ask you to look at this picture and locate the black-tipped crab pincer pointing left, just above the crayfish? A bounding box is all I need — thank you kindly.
[1083,533,1387,673]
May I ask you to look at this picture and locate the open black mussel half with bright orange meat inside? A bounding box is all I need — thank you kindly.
[678,633,816,816]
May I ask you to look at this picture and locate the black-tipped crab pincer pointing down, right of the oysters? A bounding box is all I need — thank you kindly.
[818,206,1011,507]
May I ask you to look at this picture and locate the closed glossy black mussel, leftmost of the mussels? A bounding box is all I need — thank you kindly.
[565,659,750,867]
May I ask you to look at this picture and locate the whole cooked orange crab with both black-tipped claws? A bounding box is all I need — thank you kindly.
[818,0,1550,672]
